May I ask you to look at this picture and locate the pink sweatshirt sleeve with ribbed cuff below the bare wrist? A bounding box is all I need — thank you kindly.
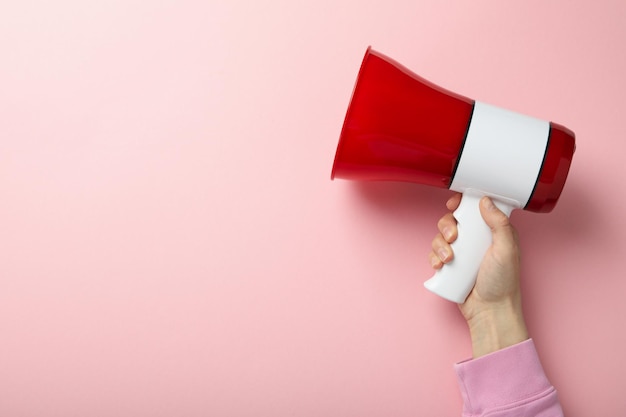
[454,339,563,417]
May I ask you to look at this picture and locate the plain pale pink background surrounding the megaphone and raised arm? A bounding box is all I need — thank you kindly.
[0,0,626,417]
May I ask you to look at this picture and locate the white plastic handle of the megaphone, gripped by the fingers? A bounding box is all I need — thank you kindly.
[424,190,515,303]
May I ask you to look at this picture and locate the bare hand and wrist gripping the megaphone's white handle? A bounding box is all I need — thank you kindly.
[429,194,528,357]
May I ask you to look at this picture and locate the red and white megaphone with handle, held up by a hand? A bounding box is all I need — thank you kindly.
[331,47,575,303]
